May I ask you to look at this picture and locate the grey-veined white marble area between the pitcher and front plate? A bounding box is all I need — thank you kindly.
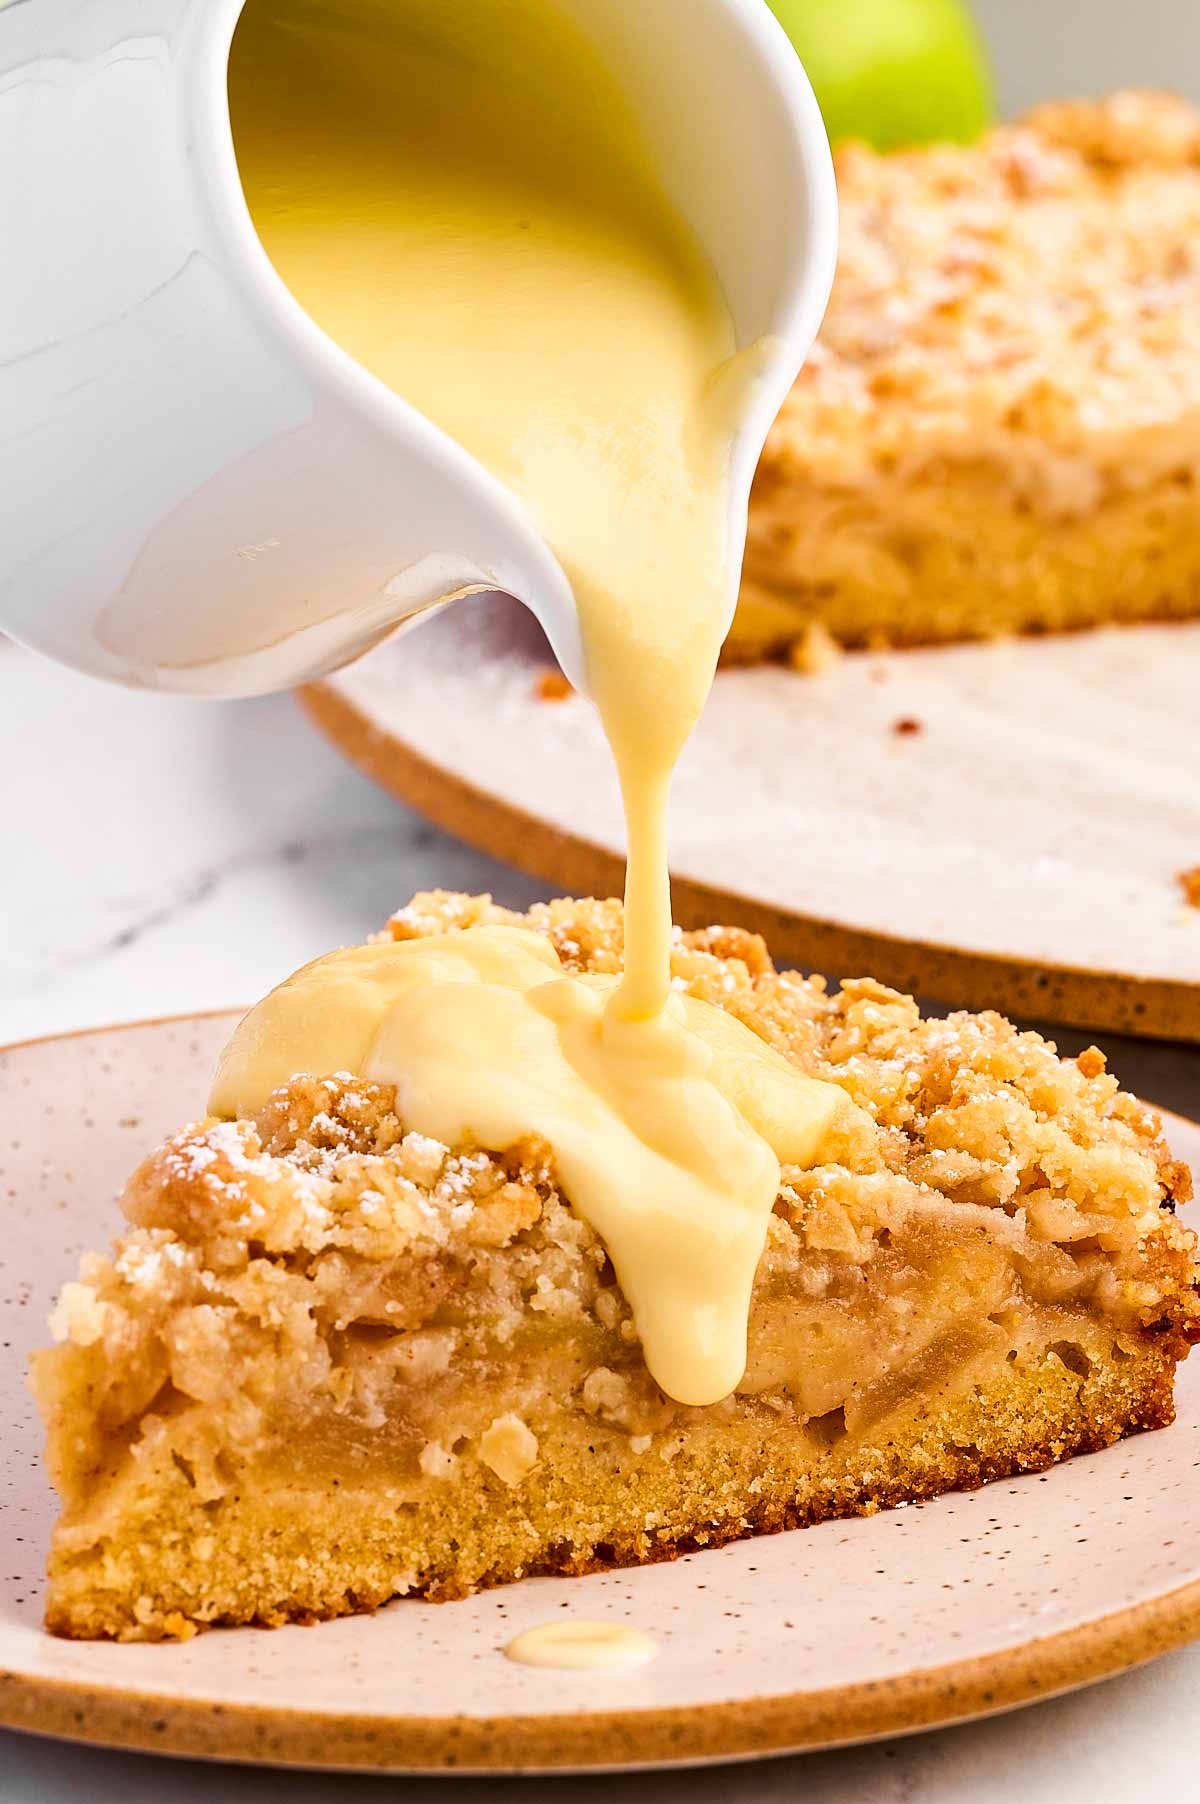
[0,644,545,1041]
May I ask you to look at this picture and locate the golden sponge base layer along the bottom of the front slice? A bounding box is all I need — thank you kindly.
[47,1335,1175,1640]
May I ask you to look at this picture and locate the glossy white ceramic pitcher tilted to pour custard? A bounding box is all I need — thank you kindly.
[0,0,835,696]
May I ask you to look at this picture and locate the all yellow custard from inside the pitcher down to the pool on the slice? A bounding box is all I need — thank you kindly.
[211,0,841,1404]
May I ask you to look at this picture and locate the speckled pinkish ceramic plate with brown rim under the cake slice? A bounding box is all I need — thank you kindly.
[0,1016,1200,1772]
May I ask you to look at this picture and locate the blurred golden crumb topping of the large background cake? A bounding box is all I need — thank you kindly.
[756,92,1200,514]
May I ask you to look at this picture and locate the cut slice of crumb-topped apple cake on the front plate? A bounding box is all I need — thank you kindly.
[32,893,1200,1640]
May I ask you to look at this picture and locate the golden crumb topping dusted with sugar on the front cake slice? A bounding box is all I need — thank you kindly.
[125,891,1189,1308]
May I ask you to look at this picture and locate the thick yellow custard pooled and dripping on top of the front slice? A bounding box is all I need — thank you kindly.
[211,927,845,1404]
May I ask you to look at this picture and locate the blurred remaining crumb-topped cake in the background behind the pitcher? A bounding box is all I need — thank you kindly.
[725,92,1200,667]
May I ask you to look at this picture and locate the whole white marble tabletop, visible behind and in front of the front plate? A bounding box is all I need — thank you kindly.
[0,642,1200,1804]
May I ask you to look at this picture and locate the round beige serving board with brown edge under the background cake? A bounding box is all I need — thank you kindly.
[303,597,1200,1041]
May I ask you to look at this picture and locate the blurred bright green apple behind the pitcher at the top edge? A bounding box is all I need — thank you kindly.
[771,0,992,150]
